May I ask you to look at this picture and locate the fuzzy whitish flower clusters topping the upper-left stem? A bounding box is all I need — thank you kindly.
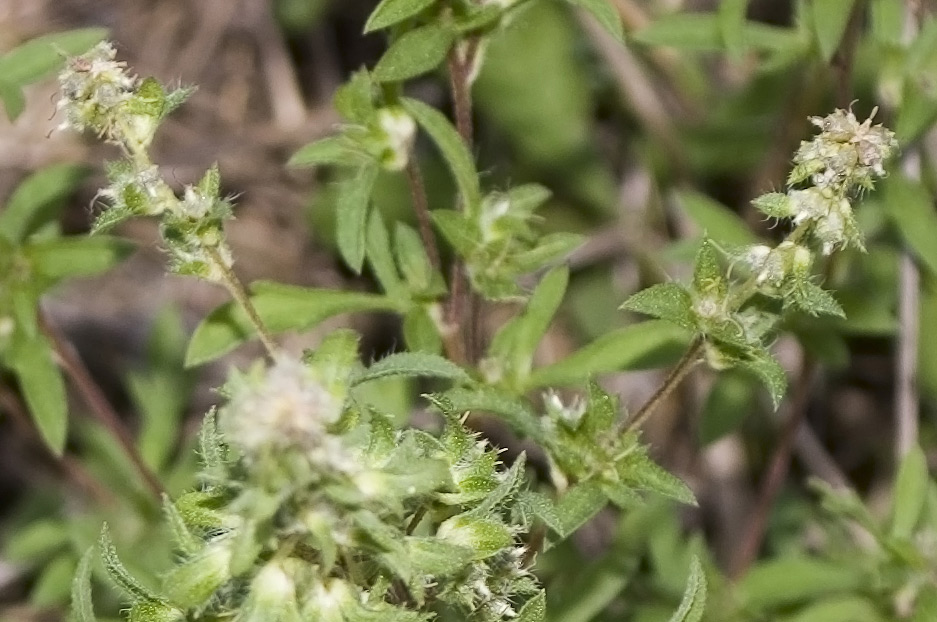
[58,42,233,282]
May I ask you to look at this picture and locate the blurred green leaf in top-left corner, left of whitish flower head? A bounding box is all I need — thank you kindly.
[0,28,107,86]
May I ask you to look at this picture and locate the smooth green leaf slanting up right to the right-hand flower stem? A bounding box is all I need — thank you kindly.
[527,320,689,389]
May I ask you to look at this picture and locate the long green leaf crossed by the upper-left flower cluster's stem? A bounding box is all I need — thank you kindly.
[185,282,401,367]
